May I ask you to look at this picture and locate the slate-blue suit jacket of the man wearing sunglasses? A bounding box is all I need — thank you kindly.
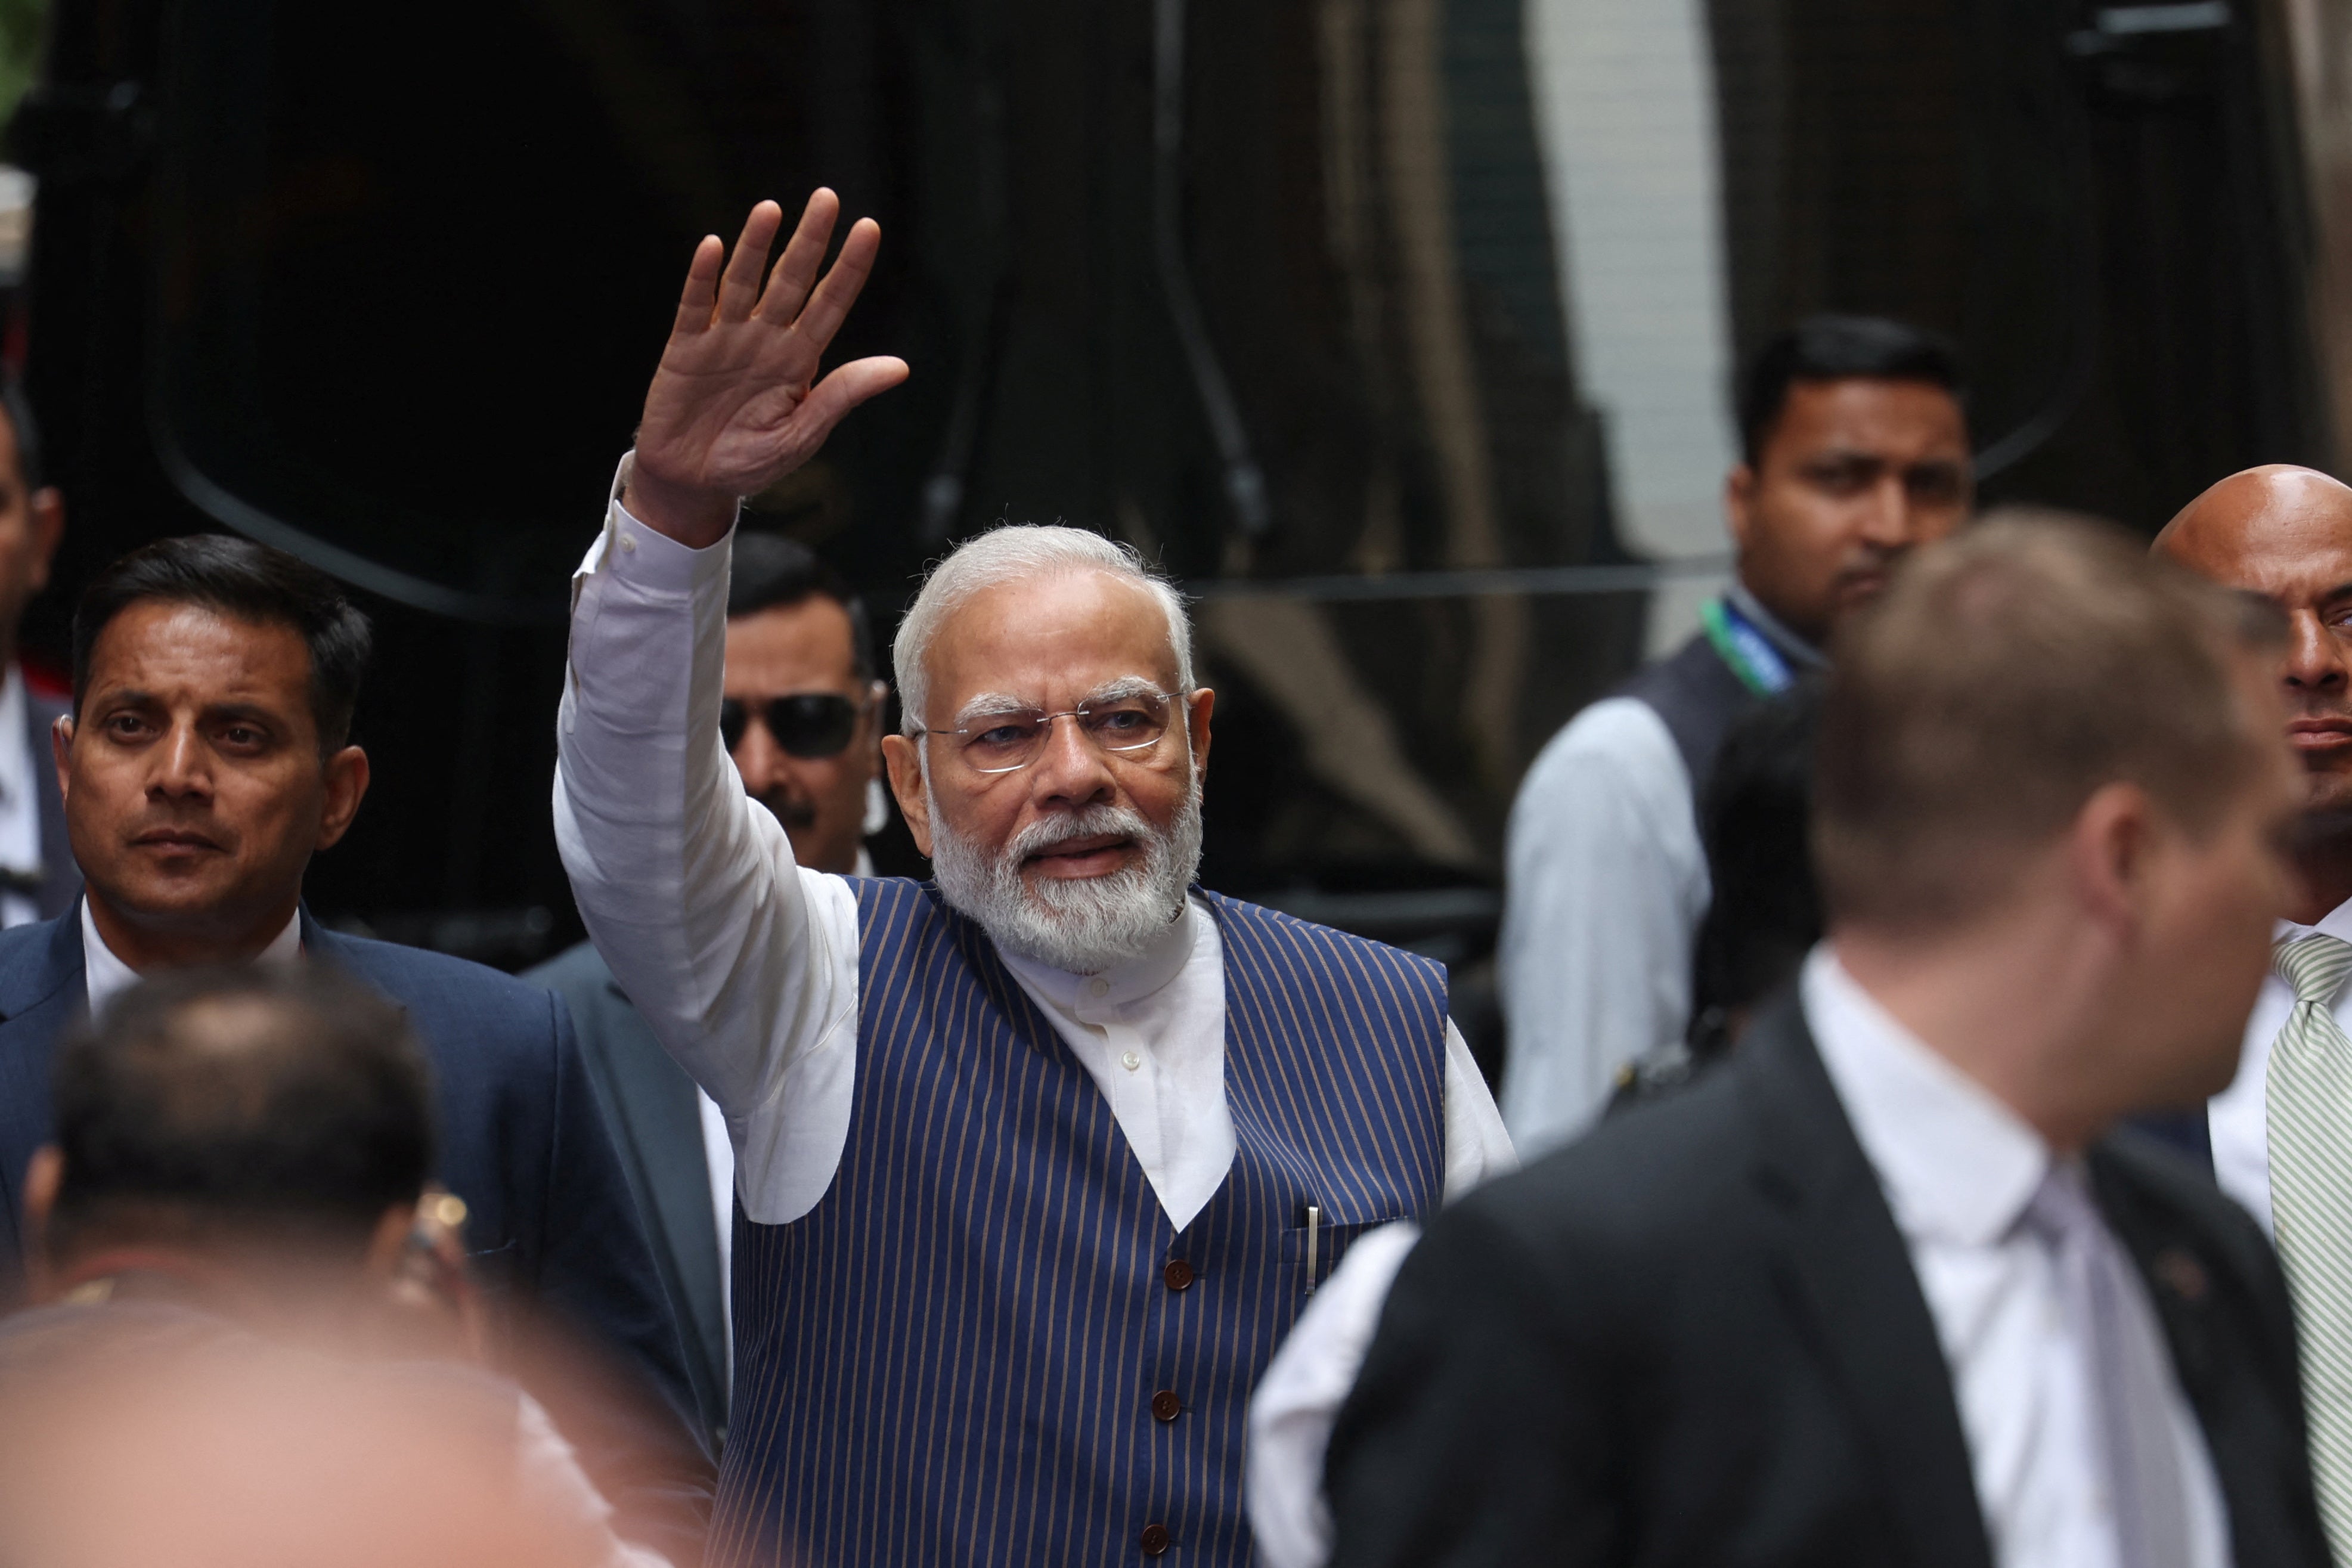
[522,943,727,1448]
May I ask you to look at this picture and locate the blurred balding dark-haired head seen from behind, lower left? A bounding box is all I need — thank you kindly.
[26,964,433,1319]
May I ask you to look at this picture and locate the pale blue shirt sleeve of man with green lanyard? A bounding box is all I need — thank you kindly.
[1501,698,1708,1159]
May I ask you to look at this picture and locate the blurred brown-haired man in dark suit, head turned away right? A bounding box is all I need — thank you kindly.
[1329,522,2329,1568]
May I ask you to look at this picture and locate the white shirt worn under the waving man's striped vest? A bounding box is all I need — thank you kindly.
[555,463,1515,1227]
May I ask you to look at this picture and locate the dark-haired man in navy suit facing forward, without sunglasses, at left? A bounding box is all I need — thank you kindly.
[0,536,710,1556]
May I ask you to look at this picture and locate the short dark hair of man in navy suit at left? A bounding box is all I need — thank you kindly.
[73,534,374,752]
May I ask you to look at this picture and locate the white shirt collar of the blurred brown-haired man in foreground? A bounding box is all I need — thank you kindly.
[1799,943,2051,1246]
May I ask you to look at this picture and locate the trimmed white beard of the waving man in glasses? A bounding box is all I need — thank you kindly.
[924,778,1200,975]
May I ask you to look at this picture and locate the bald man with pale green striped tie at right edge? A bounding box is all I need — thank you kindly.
[2157,466,2352,1561]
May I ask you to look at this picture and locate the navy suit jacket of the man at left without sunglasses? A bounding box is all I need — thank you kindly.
[0,905,710,1561]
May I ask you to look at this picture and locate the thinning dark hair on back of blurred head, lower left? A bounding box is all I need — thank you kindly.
[49,964,433,1253]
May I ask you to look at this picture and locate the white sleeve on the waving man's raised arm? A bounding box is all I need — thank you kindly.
[555,458,859,1225]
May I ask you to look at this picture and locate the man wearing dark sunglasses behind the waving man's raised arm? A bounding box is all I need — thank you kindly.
[525,534,889,1453]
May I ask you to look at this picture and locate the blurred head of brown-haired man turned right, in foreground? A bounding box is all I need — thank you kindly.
[1814,513,2300,1147]
